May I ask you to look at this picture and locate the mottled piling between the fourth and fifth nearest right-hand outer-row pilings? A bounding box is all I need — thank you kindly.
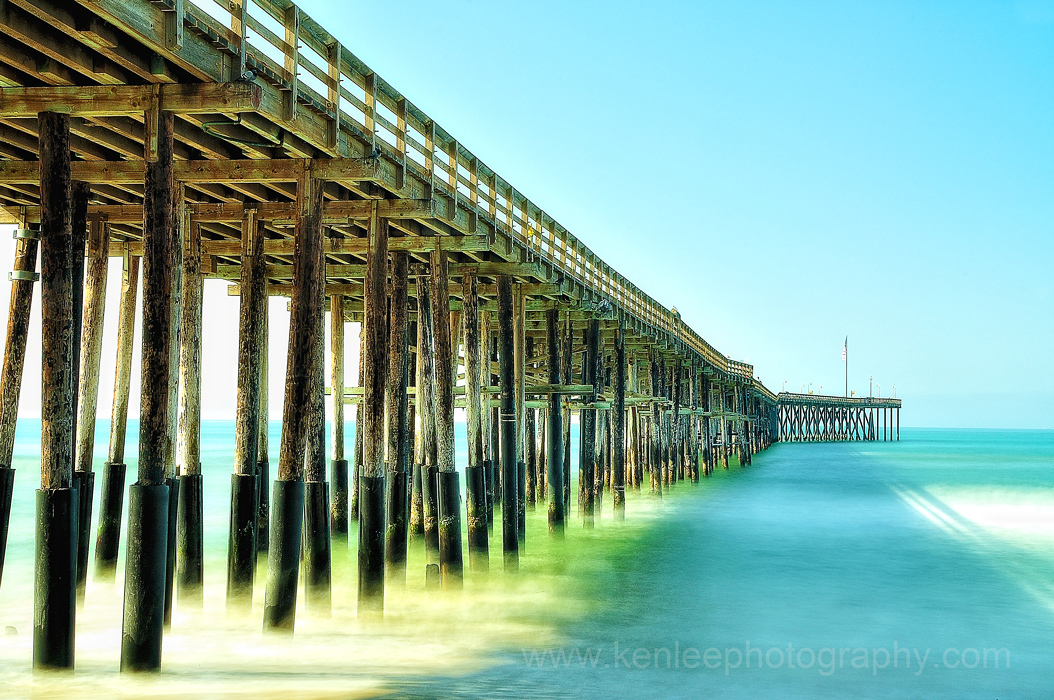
[462,274,490,571]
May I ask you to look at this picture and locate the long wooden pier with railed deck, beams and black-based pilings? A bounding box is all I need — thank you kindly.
[0,0,899,670]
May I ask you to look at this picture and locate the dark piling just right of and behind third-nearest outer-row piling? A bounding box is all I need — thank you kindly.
[385,252,410,586]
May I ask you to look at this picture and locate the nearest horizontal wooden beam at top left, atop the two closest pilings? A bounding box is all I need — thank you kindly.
[0,82,262,119]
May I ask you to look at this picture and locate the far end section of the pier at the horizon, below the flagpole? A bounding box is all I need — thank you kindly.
[774,392,901,443]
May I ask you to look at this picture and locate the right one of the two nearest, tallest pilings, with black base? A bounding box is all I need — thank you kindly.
[121,112,174,672]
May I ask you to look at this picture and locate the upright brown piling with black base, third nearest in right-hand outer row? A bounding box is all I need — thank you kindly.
[356,202,387,614]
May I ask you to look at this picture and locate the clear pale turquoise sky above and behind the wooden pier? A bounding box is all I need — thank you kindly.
[0,0,1054,428]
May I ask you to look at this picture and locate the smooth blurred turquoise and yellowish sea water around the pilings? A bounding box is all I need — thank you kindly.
[0,423,1054,699]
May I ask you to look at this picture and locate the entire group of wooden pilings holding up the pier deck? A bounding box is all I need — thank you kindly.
[0,112,773,672]
